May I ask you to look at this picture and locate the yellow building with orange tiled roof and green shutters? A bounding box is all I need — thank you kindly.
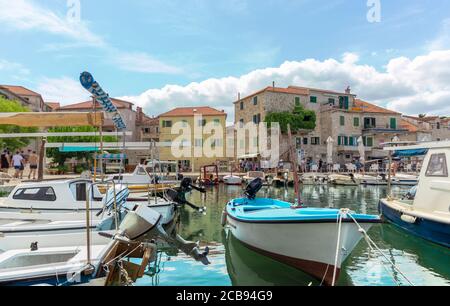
[159,107,228,171]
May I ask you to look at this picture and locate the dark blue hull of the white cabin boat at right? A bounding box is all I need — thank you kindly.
[379,201,450,247]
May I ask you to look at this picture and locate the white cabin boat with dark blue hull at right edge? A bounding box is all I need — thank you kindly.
[379,141,450,248]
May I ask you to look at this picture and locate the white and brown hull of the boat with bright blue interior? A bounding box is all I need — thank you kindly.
[227,216,372,285]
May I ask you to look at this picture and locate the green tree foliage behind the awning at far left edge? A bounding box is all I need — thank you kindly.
[0,97,37,152]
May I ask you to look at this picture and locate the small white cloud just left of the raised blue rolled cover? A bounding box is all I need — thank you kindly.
[36,77,90,105]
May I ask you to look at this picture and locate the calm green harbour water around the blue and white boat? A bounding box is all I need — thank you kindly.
[134,186,450,286]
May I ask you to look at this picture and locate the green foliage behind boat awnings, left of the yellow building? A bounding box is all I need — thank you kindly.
[47,126,117,167]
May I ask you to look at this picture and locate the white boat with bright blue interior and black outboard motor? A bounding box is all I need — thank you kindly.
[222,179,381,285]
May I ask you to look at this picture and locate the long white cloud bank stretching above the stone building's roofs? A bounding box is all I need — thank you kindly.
[123,50,450,120]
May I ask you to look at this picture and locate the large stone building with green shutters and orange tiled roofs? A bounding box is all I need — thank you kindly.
[234,86,407,163]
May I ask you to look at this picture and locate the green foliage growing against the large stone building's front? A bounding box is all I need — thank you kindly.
[265,106,317,133]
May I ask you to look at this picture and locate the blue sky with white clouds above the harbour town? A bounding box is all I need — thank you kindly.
[0,0,450,121]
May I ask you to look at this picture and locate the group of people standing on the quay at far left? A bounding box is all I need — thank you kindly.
[0,149,39,180]
